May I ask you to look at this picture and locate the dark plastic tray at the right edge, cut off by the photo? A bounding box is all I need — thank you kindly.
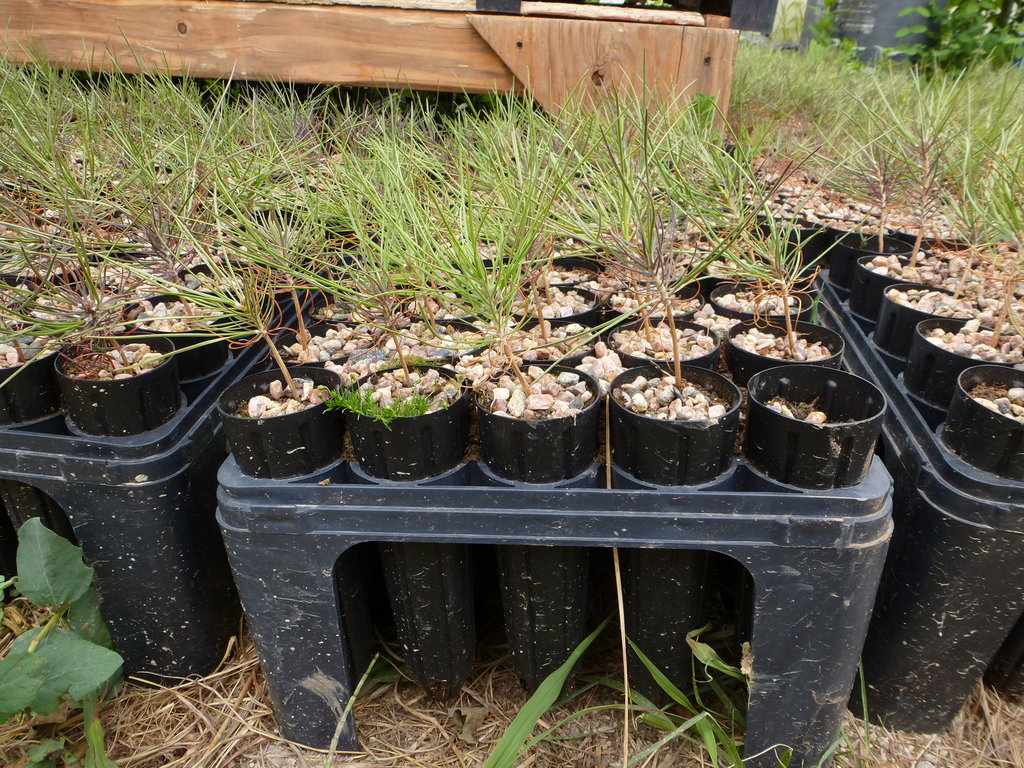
[822,274,1024,732]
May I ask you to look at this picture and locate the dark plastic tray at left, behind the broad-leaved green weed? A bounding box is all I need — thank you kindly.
[0,347,258,676]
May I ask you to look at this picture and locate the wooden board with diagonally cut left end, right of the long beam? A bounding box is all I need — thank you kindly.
[470,15,739,113]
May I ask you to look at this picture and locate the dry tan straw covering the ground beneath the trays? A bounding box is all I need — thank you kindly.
[0,614,1024,768]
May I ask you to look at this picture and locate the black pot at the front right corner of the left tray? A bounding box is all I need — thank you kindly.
[54,338,182,437]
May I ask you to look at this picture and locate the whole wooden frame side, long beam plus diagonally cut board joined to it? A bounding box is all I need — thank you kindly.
[0,0,737,112]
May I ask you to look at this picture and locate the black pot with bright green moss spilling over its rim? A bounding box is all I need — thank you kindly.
[347,366,469,480]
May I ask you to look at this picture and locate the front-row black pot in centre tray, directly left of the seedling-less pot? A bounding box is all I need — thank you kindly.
[609,366,742,485]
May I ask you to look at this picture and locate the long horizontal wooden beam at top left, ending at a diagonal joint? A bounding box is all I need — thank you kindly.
[0,0,519,93]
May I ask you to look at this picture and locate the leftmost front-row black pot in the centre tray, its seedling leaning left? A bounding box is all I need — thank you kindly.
[217,367,344,479]
